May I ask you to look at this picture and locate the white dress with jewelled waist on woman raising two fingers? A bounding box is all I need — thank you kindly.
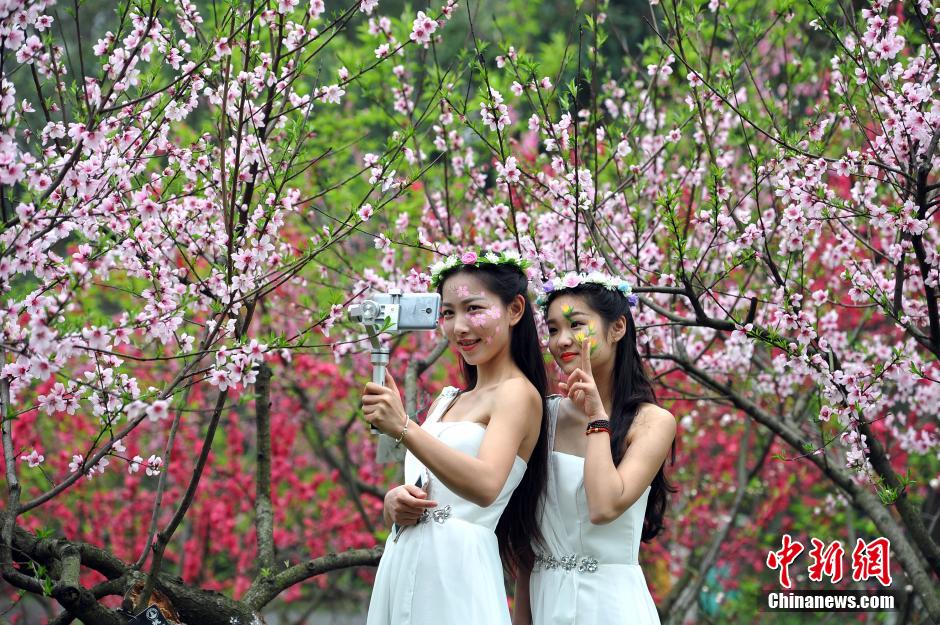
[529,397,659,625]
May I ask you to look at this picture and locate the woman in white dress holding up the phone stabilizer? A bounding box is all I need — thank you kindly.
[362,252,548,625]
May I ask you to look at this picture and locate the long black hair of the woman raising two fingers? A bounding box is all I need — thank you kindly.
[545,283,676,542]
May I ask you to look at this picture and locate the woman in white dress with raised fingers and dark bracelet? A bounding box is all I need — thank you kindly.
[513,274,676,625]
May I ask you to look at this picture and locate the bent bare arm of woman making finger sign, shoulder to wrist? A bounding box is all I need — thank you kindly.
[584,404,676,525]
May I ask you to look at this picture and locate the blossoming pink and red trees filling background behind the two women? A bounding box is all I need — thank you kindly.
[0,0,940,623]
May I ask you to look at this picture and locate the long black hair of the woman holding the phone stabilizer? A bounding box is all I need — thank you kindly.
[437,265,548,571]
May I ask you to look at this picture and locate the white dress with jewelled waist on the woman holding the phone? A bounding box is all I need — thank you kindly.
[367,387,526,625]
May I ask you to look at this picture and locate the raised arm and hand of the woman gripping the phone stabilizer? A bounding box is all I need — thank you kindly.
[362,376,542,507]
